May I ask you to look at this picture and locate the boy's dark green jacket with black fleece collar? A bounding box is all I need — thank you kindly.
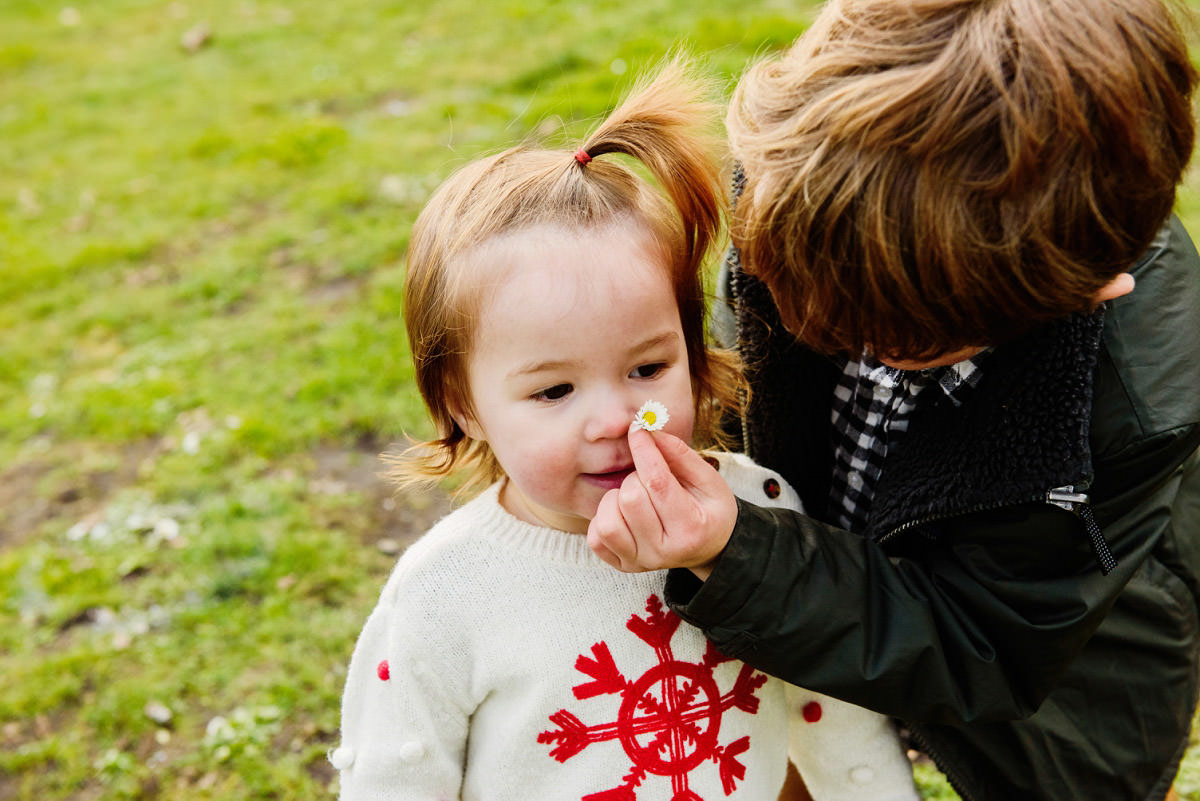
[667,219,1200,801]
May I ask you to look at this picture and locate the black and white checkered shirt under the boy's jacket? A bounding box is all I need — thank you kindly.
[829,350,988,531]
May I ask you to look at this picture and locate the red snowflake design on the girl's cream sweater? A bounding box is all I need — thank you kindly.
[538,595,767,801]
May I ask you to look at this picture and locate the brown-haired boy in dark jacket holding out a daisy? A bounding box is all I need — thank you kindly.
[589,0,1200,801]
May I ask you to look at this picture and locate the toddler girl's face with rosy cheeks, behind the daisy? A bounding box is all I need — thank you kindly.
[456,224,695,534]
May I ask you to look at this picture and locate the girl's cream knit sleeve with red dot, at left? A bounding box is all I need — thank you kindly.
[330,568,470,801]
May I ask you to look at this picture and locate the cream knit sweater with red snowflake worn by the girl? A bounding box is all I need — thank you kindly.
[330,454,917,801]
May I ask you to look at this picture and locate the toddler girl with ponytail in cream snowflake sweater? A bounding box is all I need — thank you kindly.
[331,62,916,801]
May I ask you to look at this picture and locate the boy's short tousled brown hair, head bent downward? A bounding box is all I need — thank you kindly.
[726,0,1195,360]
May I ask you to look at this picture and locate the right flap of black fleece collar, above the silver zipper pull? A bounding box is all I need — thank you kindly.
[869,311,1104,536]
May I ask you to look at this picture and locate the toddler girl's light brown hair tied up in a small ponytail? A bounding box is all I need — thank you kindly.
[388,58,740,488]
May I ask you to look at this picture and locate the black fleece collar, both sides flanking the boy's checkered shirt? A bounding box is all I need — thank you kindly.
[731,269,1104,537]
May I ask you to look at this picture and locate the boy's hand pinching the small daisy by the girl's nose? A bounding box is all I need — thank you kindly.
[588,428,738,579]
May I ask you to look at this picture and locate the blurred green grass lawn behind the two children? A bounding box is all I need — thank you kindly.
[0,0,1200,801]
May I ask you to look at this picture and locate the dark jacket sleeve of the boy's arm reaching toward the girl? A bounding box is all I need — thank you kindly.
[666,431,1195,723]
